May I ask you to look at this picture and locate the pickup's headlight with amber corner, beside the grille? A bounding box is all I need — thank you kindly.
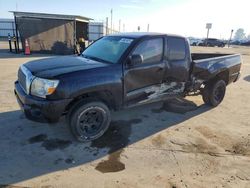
[31,78,59,98]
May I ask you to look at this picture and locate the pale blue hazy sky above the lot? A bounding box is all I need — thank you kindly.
[0,0,250,39]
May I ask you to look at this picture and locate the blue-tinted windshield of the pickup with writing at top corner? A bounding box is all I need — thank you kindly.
[82,37,133,64]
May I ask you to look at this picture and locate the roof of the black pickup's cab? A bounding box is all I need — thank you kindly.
[109,32,184,38]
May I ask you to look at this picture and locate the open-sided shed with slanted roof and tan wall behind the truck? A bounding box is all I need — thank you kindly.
[12,11,92,54]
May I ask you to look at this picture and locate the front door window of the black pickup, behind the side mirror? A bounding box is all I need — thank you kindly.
[133,38,163,63]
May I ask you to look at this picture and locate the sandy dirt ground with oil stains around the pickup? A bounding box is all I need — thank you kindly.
[0,44,250,188]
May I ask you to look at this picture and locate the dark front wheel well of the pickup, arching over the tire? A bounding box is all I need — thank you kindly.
[64,91,116,114]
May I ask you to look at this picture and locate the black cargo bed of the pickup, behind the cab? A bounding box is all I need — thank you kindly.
[191,53,241,84]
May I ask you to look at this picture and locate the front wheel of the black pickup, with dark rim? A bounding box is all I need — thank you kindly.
[67,100,111,142]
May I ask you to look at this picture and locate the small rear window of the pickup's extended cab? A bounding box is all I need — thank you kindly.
[168,38,186,61]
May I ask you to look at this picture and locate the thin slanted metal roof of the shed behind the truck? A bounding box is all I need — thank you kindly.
[10,11,93,22]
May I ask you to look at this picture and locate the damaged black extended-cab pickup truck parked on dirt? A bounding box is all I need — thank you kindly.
[14,33,241,141]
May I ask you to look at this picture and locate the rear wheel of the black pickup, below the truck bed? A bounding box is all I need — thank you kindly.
[202,80,226,107]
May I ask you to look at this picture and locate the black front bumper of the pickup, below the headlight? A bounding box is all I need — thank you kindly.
[14,81,71,122]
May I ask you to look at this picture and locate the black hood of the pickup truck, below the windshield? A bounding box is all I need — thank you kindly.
[24,56,108,78]
